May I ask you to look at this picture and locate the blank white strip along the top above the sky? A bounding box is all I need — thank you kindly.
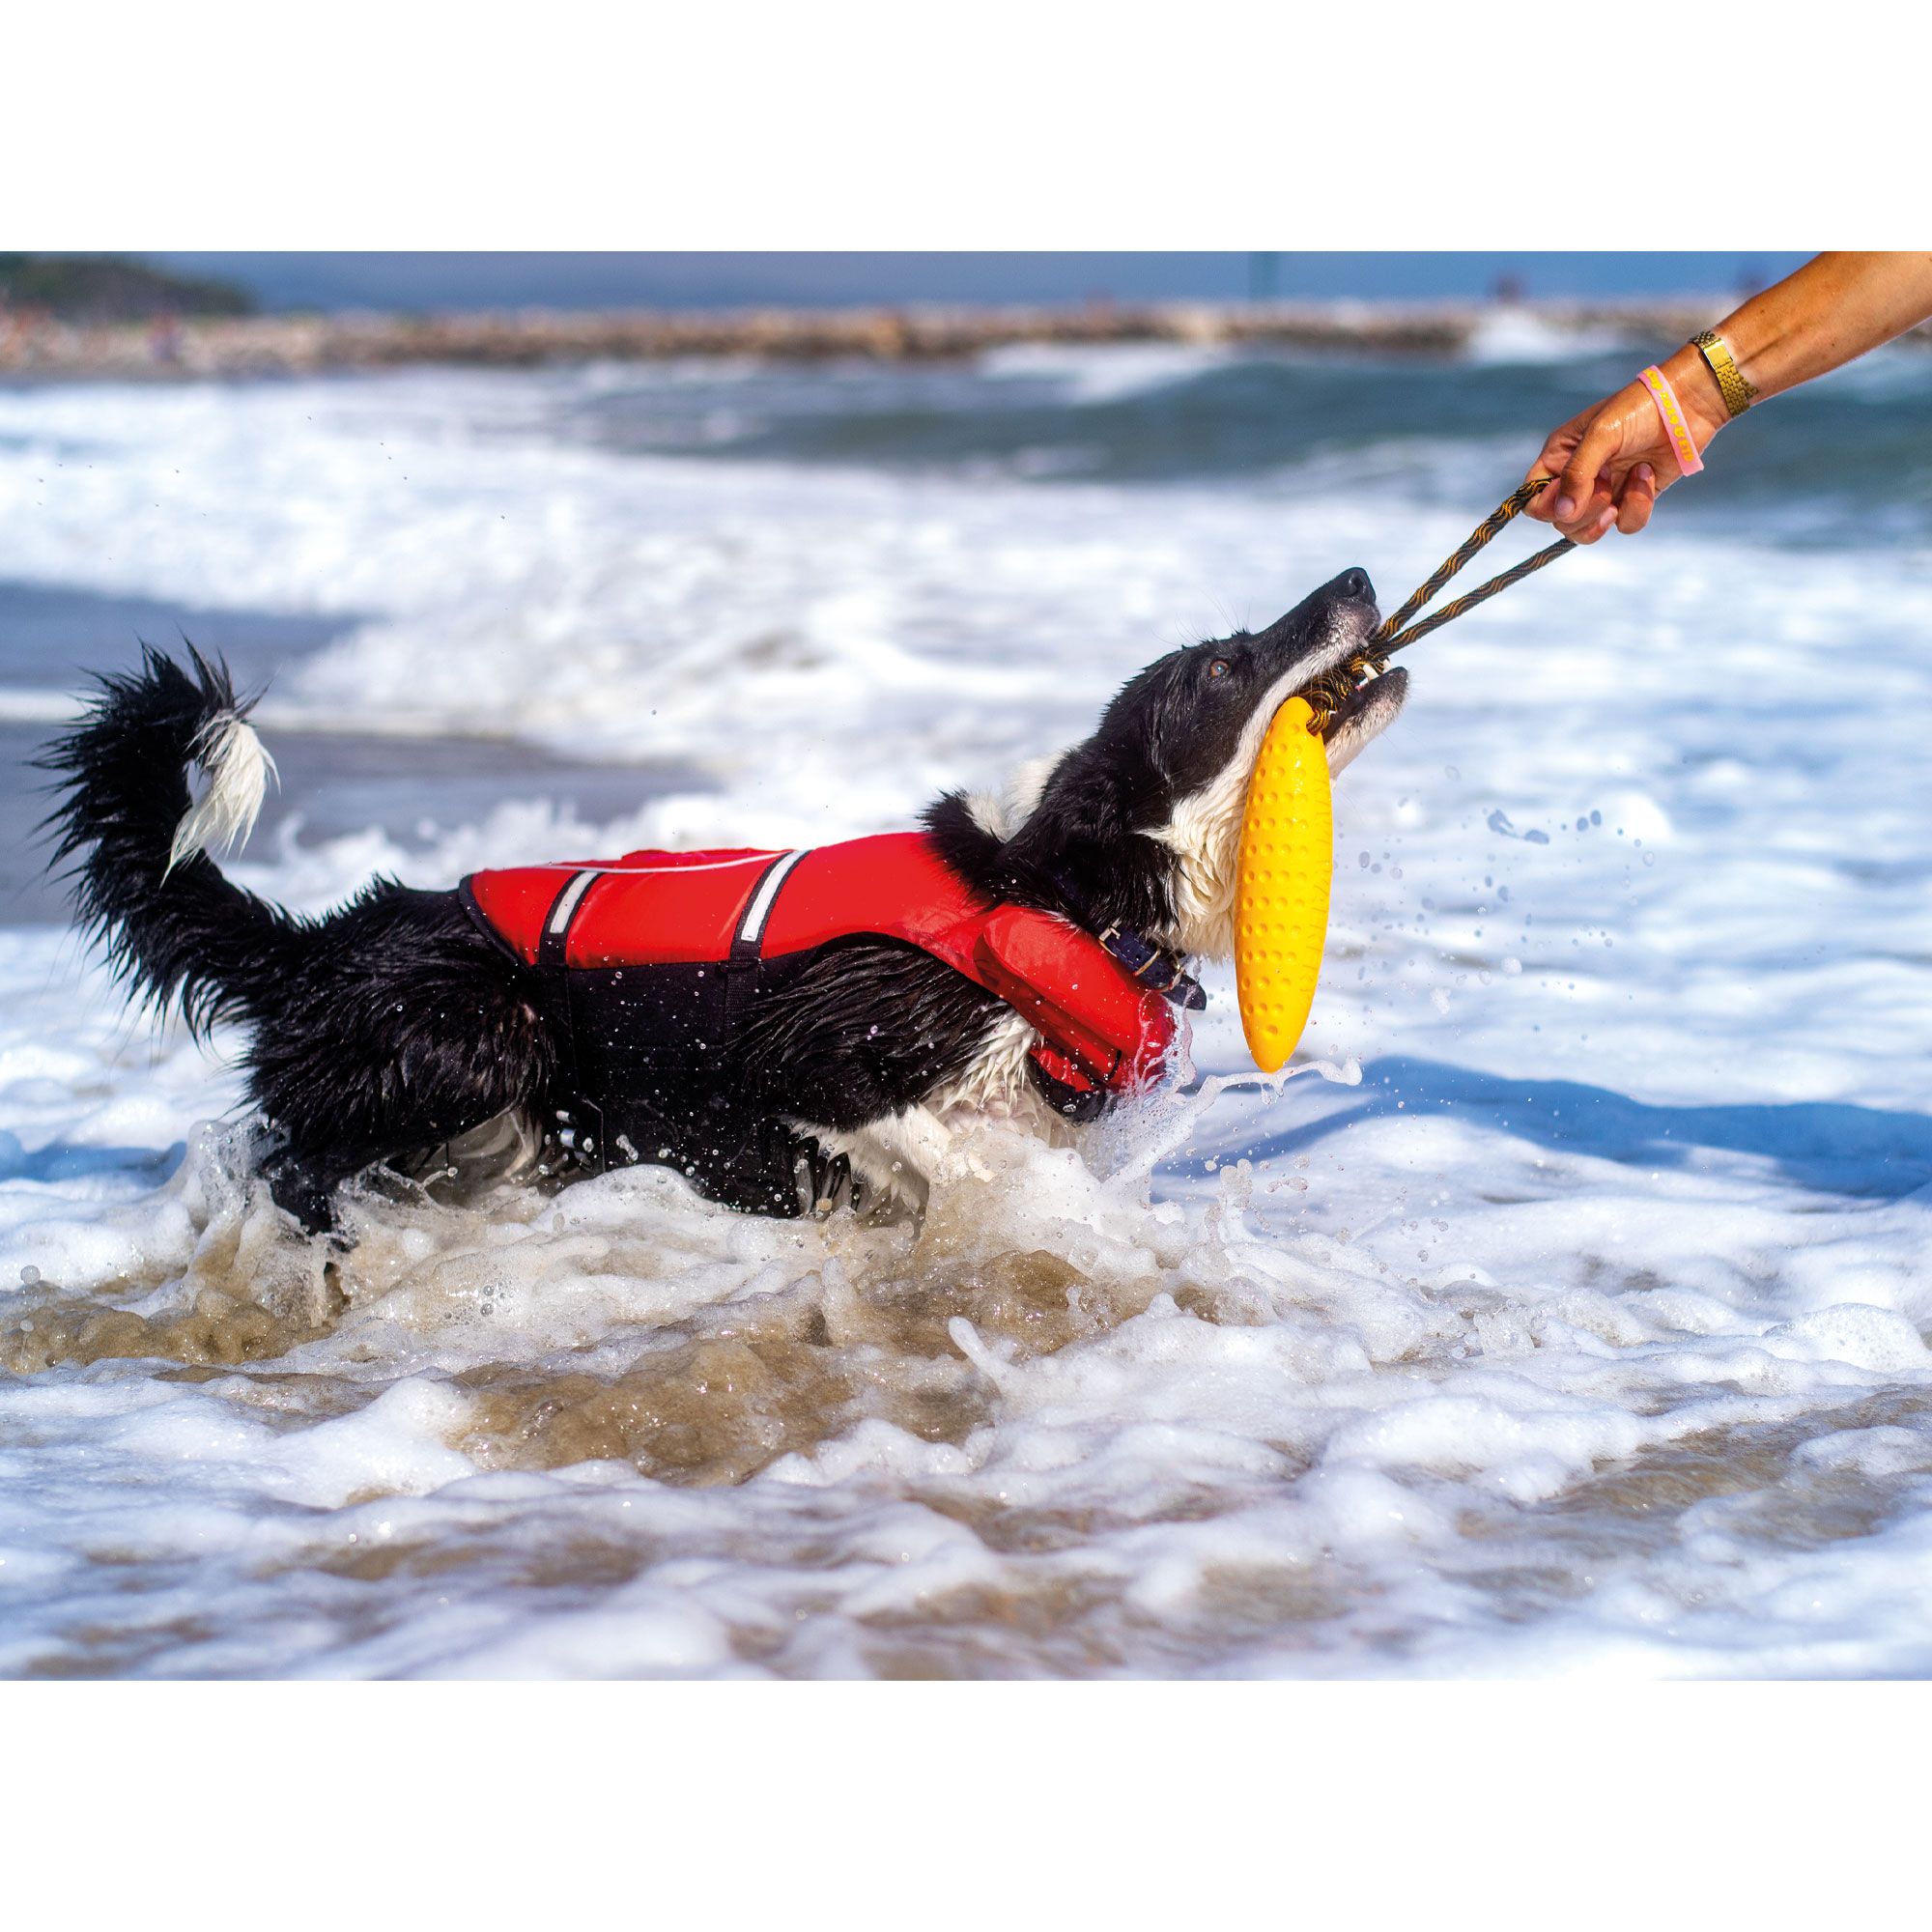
[0,0,1924,251]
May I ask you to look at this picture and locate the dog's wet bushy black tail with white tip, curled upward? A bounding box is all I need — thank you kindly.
[37,649,305,1032]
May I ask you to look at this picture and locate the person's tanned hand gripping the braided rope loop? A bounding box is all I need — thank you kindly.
[1524,348,1729,543]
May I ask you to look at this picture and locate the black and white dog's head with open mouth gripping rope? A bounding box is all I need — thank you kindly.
[929,570,1408,958]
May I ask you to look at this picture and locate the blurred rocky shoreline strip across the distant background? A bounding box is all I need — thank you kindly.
[0,296,1932,379]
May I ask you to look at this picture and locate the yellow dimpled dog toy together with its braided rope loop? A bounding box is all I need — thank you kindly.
[1235,477,1577,1074]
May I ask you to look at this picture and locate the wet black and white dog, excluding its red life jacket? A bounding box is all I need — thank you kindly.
[43,570,1406,1229]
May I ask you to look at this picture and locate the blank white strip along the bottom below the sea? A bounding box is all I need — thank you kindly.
[0,1683,1926,1932]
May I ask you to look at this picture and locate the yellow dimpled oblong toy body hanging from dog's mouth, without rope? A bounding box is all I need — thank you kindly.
[1235,697,1335,1074]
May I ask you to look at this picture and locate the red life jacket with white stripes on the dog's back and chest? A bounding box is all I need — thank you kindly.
[462,833,1175,1094]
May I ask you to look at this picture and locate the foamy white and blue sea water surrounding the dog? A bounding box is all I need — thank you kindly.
[0,336,1932,1677]
